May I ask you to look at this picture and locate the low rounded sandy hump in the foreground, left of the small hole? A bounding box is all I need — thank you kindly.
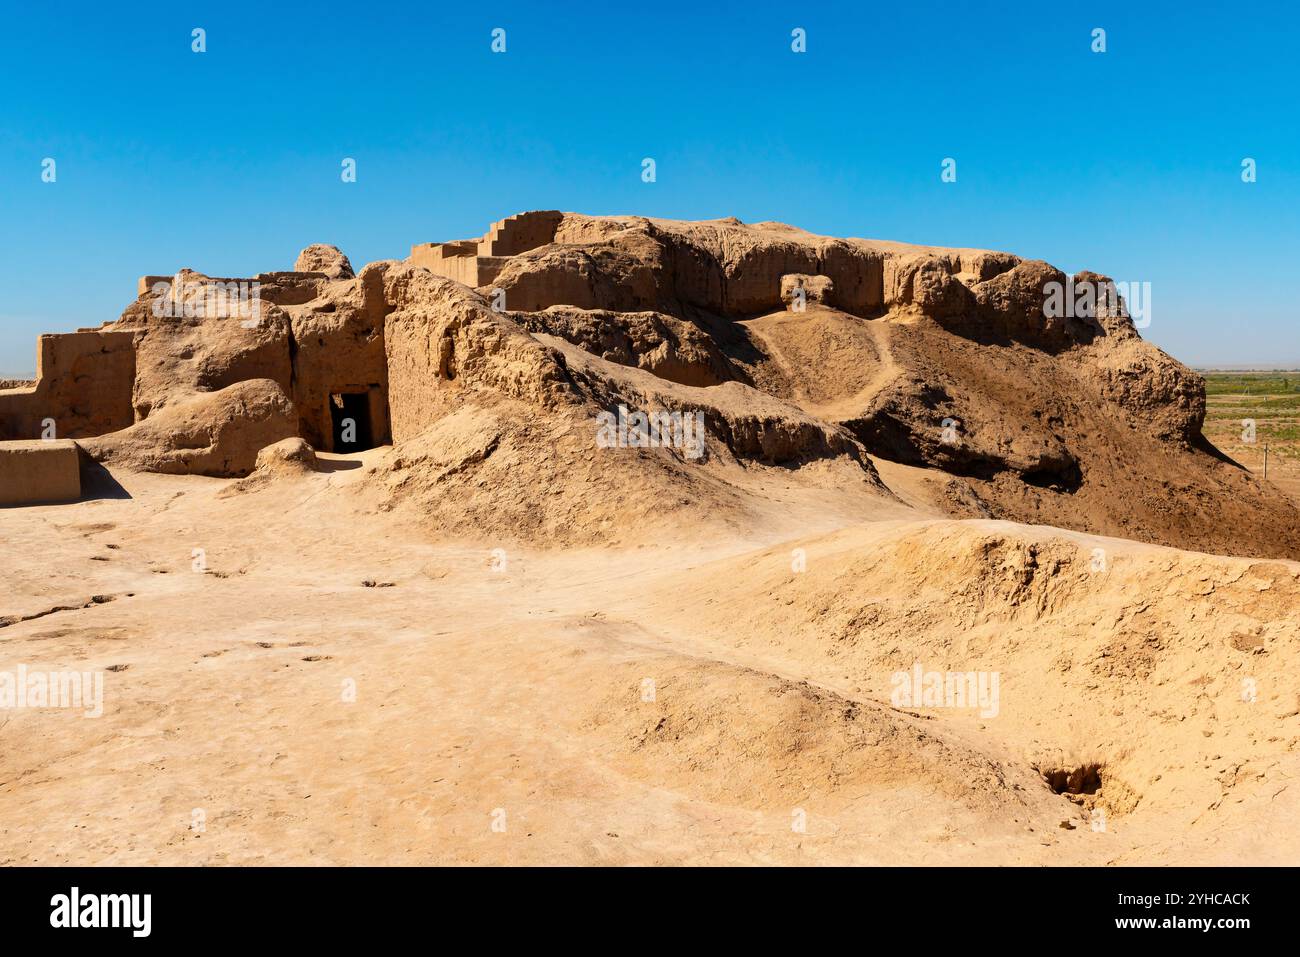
[586,661,1062,824]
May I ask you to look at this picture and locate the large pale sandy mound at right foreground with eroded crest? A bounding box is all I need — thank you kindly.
[621,521,1300,823]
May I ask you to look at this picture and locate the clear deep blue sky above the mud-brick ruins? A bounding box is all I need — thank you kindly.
[0,0,1300,373]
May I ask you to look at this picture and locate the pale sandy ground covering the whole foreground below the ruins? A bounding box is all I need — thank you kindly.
[0,450,1300,865]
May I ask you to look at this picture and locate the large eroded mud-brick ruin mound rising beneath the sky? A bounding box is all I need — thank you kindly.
[81,213,1300,558]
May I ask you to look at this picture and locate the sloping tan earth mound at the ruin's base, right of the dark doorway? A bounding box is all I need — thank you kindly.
[369,369,893,547]
